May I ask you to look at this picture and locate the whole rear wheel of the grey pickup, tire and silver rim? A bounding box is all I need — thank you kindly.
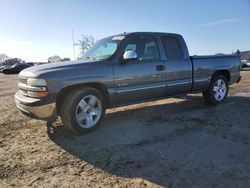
[203,75,228,105]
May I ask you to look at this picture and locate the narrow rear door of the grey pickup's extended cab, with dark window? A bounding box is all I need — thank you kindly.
[161,36,192,96]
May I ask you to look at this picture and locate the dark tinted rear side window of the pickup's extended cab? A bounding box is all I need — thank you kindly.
[161,37,184,59]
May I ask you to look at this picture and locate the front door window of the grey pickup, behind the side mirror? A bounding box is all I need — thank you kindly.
[124,36,159,60]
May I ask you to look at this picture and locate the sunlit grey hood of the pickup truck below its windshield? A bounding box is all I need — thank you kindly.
[19,60,96,78]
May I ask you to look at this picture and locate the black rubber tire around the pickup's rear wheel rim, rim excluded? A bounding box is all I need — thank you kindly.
[203,74,228,105]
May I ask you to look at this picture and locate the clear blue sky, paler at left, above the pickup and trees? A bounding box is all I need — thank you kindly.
[0,0,250,62]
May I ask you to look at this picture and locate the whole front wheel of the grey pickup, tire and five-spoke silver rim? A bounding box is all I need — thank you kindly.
[60,88,105,133]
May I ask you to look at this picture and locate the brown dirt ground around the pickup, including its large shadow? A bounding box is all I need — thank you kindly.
[0,71,250,188]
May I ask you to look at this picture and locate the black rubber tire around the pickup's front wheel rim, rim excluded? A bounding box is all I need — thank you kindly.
[60,88,105,134]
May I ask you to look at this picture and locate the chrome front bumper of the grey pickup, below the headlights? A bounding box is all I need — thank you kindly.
[15,91,57,121]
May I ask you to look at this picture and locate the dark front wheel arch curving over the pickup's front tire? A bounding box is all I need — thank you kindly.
[56,83,110,115]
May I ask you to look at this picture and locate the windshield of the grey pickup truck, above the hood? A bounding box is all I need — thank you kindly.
[83,36,124,60]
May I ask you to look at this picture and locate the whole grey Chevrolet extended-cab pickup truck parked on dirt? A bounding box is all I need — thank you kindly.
[15,32,241,133]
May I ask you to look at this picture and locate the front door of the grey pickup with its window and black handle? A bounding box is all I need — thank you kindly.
[114,35,166,105]
